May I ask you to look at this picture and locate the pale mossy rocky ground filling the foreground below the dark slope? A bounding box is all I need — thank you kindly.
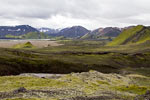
[0,71,150,100]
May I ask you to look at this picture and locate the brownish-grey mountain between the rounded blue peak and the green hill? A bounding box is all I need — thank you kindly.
[81,27,121,39]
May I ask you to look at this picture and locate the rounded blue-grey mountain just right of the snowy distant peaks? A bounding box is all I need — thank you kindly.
[49,26,90,38]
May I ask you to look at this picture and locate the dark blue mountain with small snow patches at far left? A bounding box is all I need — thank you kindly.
[0,25,39,37]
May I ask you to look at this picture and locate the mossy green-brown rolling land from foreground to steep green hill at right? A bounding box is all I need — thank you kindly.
[0,25,150,100]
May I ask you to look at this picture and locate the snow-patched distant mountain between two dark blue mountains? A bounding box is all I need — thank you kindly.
[37,27,60,35]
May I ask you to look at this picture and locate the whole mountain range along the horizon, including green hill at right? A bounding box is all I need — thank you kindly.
[0,25,150,40]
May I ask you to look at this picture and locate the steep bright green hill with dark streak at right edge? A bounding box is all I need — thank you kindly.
[108,25,150,46]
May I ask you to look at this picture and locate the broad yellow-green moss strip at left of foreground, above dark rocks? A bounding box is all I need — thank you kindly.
[0,77,67,91]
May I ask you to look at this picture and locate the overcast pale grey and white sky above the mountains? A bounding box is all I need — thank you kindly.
[0,0,150,29]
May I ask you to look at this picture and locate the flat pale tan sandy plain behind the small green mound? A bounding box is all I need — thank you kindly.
[0,40,62,48]
